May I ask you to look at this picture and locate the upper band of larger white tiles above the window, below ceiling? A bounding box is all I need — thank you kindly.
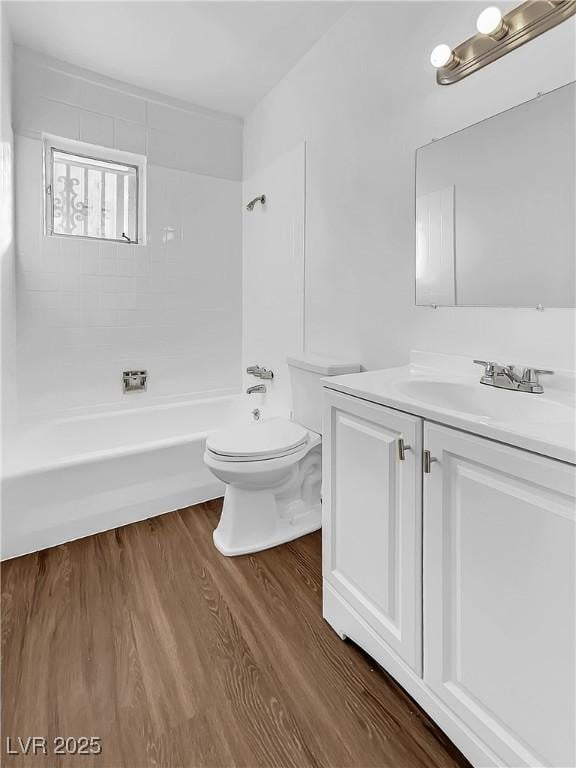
[13,47,242,181]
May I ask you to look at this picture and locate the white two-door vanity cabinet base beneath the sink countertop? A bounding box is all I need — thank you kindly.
[323,389,576,766]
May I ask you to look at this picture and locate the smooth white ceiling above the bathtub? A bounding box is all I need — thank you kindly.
[5,0,349,116]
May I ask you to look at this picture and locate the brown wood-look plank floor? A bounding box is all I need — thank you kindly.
[2,501,468,768]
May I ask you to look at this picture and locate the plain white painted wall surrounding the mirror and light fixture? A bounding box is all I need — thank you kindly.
[244,2,575,376]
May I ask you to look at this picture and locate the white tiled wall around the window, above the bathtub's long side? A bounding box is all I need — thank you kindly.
[14,48,242,416]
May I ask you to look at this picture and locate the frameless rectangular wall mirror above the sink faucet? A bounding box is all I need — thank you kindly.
[416,83,576,307]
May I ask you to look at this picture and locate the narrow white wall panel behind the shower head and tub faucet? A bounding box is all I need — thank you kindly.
[242,144,306,415]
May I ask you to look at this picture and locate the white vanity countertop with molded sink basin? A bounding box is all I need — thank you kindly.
[323,352,576,464]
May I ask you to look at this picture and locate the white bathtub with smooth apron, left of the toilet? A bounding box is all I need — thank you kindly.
[1,395,278,559]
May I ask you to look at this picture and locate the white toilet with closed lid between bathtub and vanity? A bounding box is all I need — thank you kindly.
[204,354,360,555]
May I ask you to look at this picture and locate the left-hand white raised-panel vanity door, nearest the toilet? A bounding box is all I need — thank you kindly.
[322,389,422,674]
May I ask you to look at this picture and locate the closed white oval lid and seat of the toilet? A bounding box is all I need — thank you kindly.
[206,419,308,459]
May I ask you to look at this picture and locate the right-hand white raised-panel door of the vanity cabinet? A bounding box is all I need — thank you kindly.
[424,424,576,766]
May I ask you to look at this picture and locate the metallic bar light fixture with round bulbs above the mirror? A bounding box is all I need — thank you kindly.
[430,0,576,85]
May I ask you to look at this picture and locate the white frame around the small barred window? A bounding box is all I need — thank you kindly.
[42,134,147,245]
